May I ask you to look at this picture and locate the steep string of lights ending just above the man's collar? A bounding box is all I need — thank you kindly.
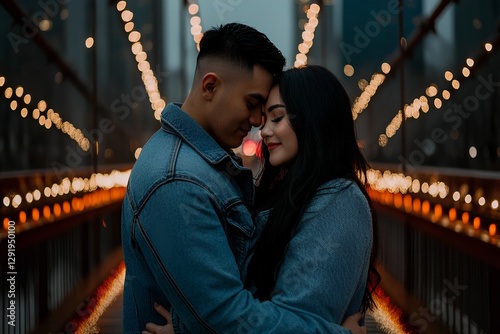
[116,1,167,120]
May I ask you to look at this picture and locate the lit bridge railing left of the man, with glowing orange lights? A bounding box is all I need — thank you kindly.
[0,166,130,333]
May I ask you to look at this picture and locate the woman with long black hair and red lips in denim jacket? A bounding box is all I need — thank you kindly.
[148,66,380,332]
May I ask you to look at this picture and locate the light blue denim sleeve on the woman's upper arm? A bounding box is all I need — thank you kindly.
[272,180,372,324]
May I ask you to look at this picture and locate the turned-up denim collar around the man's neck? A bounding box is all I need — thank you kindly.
[161,103,242,167]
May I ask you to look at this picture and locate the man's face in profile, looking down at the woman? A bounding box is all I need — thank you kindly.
[206,65,273,148]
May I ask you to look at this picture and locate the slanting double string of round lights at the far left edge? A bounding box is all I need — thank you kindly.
[0,76,90,151]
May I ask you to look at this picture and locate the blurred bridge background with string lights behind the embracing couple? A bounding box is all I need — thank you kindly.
[0,0,500,333]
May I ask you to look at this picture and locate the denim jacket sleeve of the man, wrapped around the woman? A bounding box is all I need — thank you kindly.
[135,181,349,334]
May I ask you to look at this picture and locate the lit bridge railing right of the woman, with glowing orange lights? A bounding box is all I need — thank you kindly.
[369,165,500,333]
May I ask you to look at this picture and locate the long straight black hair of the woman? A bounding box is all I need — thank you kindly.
[247,65,380,311]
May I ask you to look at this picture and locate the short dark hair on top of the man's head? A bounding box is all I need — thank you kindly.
[197,23,285,75]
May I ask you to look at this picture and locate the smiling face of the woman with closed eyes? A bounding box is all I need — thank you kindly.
[261,86,298,167]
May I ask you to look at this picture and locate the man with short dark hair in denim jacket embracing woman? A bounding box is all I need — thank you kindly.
[122,24,364,334]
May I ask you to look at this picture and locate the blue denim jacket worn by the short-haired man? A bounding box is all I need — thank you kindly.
[122,104,349,334]
